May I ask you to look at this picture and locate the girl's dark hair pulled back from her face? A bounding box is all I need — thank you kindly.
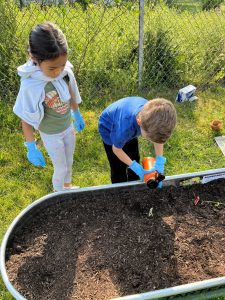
[28,22,68,63]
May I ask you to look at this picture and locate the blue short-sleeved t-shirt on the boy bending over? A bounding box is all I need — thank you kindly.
[98,97,148,148]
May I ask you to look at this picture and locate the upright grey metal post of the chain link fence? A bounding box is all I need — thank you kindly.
[138,0,145,90]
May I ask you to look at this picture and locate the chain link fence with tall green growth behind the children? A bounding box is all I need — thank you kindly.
[0,0,225,105]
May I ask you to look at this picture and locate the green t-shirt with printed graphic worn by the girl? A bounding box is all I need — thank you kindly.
[38,78,72,134]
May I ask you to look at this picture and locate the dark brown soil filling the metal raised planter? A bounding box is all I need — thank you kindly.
[7,179,225,300]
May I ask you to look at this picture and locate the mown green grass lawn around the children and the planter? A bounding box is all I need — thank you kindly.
[0,88,225,300]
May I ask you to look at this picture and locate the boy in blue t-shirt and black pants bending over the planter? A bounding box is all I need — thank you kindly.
[98,97,177,183]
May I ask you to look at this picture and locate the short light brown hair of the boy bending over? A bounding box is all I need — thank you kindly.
[140,98,177,144]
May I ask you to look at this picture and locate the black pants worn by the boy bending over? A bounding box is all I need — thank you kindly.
[103,138,140,183]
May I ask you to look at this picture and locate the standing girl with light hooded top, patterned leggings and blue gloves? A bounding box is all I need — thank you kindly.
[13,22,84,191]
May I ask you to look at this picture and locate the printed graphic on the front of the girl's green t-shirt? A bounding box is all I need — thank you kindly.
[45,90,69,115]
